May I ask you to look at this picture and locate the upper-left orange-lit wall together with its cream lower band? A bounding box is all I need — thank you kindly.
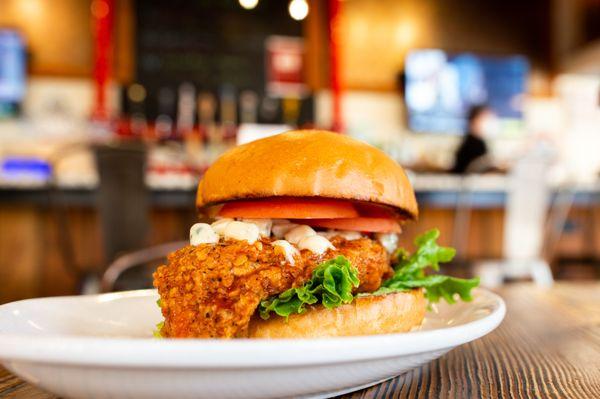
[0,0,135,118]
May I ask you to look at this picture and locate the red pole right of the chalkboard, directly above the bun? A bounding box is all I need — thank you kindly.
[329,0,344,132]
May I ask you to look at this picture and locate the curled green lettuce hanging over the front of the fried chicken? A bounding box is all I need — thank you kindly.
[259,256,359,320]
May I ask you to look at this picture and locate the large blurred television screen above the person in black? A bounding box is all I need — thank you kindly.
[405,50,529,135]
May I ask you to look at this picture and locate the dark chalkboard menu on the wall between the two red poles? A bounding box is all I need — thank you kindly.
[135,0,302,119]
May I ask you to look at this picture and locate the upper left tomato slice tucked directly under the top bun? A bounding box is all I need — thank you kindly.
[219,197,358,219]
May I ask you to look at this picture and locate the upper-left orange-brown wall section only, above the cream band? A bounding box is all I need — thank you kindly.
[0,0,135,82]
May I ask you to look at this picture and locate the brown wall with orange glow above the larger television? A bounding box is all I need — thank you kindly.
[340,0,550,91]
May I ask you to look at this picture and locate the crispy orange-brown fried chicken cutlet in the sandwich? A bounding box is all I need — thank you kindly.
[154,236,393,338]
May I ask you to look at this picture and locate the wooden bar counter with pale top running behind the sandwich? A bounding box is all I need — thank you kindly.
[0,174,600,303]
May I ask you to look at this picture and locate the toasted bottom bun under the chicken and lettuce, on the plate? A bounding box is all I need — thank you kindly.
[249,289,426,338]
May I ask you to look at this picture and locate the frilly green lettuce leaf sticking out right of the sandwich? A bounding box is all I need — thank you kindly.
[373,229,479,304]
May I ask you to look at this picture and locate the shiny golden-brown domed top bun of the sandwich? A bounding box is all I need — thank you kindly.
[196,130,418,219]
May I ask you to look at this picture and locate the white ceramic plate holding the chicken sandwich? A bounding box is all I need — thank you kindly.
[0,289,505,399]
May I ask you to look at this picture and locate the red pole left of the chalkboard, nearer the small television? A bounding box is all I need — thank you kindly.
[91,0,114,120]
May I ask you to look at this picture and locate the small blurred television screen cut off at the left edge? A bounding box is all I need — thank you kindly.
[0,29,26,105]
